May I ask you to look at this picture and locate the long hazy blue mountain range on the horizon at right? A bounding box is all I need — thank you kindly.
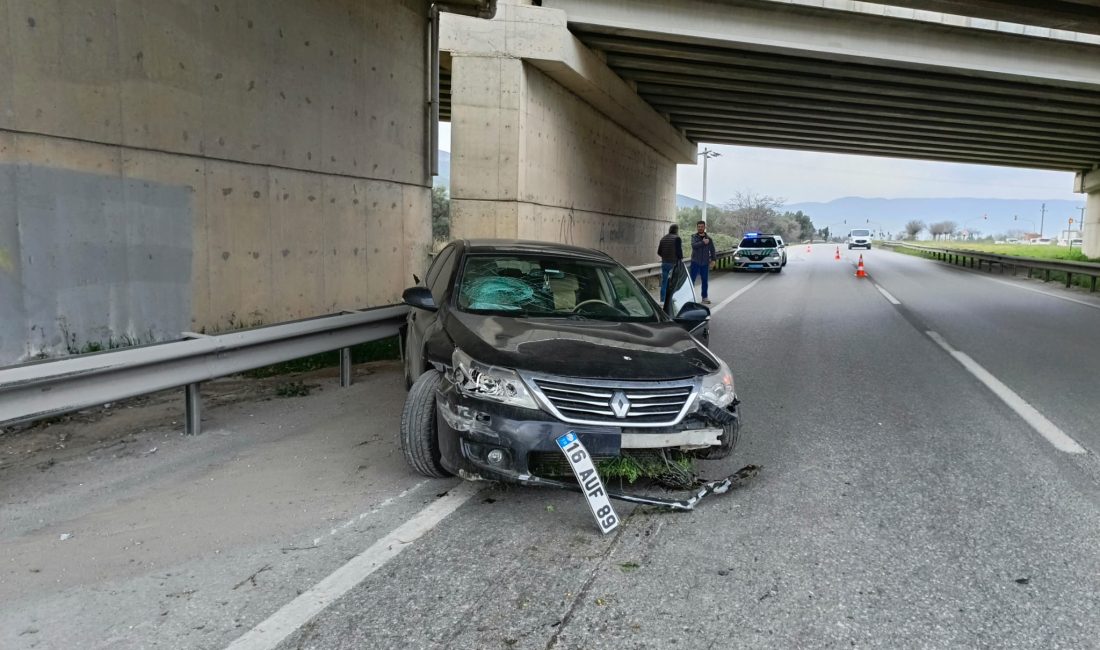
[783,197,1085,234]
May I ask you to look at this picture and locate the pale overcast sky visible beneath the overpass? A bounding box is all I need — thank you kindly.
[439,122,1082,205]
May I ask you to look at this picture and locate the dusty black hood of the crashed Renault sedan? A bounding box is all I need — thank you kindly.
[446,311,718,381]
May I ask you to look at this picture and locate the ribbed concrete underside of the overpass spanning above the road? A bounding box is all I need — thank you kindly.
[443,0,1100,256]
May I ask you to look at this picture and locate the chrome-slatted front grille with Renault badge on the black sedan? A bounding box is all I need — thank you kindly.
[532,377,695,427]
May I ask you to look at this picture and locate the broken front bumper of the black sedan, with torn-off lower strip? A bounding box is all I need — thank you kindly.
[436,378,747,510]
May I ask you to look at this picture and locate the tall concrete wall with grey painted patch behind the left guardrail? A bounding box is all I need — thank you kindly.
[0,0,431,364]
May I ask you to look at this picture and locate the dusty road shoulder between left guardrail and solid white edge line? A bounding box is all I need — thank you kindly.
[0,362,453,649]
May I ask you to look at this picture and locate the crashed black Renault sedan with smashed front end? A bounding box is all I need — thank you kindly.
[400,240,739,485]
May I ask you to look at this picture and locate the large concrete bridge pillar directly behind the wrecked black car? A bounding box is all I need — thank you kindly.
[440,3,695,264]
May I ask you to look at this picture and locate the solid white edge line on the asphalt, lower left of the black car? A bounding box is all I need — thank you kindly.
[227,481,483,650]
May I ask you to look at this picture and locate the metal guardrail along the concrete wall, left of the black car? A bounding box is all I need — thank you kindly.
[0,305,408,433]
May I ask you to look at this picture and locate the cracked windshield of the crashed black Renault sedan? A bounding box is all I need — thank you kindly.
[458,255,658,322]
